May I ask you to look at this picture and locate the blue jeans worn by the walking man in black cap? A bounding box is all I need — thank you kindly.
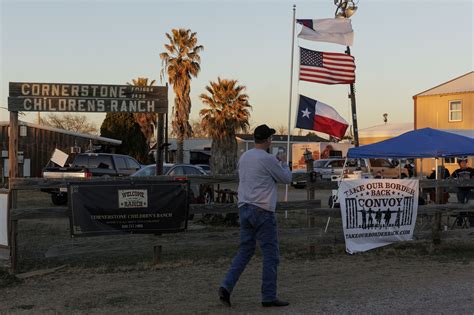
[221,204,280,302]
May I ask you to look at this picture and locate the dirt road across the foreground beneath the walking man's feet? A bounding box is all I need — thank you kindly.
[0,256,474,314]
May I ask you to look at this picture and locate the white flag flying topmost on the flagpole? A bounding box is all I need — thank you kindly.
[296,18,354,46]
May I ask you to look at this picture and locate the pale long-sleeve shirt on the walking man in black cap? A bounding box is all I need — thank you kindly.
[238,149,291,212]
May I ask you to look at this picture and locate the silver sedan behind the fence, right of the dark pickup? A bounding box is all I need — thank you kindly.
[132,164,214,203]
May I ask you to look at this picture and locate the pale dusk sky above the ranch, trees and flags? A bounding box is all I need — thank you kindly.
[0,0,474,136]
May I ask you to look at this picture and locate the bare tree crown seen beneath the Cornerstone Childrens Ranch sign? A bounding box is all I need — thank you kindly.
[41,114,99,134]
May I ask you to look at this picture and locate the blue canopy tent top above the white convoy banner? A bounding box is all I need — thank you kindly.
[347,128,474,159]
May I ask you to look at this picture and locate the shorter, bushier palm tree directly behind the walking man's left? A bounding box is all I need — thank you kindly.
[199,78,252,174]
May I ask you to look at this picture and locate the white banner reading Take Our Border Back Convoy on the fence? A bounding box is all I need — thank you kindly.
[338,179,418,254]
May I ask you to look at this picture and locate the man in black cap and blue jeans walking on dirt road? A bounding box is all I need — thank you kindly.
[219,125,291,307]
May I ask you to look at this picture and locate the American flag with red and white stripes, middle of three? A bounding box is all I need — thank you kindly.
[300,47,355,84]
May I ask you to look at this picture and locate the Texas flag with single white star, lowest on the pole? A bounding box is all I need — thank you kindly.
[296,95,349,139]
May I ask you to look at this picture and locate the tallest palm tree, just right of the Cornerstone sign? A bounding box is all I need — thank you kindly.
[160,29,203,163]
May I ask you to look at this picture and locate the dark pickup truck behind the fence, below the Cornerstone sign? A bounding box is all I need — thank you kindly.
[41,153,141,205]
